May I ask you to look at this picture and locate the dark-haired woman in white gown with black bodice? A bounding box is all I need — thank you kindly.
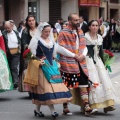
[85,20,115,113]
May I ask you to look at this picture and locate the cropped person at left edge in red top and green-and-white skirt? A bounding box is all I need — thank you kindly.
[0,31,13,92]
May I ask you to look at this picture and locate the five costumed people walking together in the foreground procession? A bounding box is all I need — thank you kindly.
[0,13,115,118]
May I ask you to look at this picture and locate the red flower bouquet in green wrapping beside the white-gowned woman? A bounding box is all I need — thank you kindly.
[103,50,116,72]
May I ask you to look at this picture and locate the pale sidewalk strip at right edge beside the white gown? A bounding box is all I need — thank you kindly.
[110,53,120,104]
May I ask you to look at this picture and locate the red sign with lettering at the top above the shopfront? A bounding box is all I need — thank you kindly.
[79,0,100,7]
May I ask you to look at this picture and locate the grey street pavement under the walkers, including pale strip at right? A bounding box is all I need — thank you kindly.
[0,53,120,120]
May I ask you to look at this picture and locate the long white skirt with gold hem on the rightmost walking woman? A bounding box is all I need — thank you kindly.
[86,56,115,108]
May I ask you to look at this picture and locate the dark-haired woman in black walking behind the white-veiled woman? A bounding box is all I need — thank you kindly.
[18,15,38,92]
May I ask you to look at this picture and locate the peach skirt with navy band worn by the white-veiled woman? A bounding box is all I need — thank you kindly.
[30,68,72,105]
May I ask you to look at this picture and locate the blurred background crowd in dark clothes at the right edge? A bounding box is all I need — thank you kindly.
[99,18,120,52]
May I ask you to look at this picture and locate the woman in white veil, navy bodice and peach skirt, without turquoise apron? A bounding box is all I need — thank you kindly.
[29,22,72,118]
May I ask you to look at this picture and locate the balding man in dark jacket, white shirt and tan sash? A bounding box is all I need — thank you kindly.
[3,21,21,88]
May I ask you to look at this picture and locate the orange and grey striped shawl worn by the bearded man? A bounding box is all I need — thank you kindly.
[57,25,88,76]
